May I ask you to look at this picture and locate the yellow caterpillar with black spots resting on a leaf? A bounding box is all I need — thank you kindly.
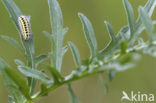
[18,15,31,41]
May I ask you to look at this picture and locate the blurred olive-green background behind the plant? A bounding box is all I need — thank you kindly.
[0,0,156,103]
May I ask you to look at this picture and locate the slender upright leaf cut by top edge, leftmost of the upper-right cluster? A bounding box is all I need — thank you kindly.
[123,0,135,37]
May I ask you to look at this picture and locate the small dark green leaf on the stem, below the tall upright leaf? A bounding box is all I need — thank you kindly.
[47,65,63,82]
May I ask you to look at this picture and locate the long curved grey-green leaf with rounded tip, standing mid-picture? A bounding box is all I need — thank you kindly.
[78,13,98,57]
